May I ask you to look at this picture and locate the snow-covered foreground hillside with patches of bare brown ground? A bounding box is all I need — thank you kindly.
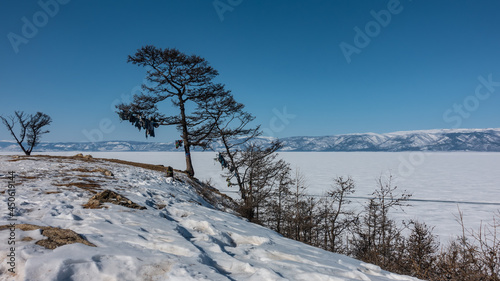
[0,156,422,281]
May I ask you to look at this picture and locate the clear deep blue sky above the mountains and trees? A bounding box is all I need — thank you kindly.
[0,0,500,142]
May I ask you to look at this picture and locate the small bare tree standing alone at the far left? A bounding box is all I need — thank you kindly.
[0,111,52,155]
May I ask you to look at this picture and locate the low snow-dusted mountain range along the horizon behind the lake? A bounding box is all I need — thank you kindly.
[0,129,500,152]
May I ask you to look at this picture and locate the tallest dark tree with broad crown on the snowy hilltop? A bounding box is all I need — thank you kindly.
[117,46,228,175]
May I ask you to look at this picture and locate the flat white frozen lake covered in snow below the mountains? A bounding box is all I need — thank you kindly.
[2,152,500,242]
